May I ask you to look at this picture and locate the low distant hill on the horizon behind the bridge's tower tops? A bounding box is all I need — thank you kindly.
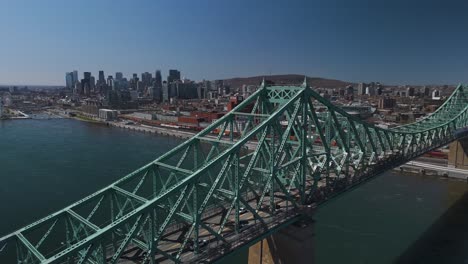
[224,74,355,89]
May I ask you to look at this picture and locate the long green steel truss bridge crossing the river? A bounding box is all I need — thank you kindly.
[0,79,468,264]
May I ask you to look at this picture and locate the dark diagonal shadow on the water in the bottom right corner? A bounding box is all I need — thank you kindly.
[396,190,468,264]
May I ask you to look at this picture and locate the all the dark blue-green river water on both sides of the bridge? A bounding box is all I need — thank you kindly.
[0,119,468,263]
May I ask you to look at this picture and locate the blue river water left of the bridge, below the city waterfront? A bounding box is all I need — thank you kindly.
[0,119,181,236]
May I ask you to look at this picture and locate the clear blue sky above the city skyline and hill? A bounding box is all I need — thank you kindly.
[0,0,468,85]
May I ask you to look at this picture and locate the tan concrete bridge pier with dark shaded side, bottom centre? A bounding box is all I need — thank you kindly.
[249,221,314,264]
